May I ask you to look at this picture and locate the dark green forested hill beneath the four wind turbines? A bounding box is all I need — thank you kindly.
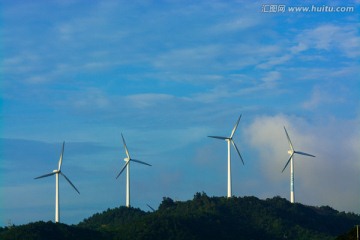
[0,193,360,240]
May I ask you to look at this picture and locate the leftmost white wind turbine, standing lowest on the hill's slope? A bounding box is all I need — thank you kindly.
[34,142,80,223]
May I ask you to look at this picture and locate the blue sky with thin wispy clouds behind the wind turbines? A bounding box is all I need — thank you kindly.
[0,0,360,225]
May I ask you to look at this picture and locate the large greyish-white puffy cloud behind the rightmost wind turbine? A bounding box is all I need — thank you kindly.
[247,115,360,212]
